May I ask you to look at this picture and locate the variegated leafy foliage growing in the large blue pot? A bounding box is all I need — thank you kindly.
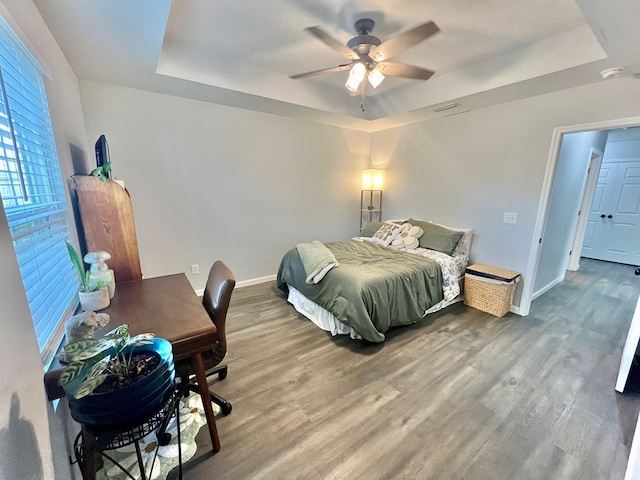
[60,324,155,398]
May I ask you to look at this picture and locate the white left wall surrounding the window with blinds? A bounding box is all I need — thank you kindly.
[0,0,87,480]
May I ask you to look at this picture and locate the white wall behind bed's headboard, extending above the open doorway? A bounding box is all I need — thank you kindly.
[371,79,640,306]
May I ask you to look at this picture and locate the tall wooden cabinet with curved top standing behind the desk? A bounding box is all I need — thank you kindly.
[71,175,142,284]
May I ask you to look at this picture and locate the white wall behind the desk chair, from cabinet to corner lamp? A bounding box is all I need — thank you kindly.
[80,81,369,290]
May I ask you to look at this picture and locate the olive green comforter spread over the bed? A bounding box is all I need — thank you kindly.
[277,240,443,343]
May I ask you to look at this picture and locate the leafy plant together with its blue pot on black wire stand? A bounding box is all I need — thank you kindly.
[60,324,175,430]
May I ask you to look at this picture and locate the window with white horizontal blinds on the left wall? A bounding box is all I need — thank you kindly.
[0,18,78,365]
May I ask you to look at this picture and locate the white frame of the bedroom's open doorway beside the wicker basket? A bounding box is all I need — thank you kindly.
[518,117,640,316]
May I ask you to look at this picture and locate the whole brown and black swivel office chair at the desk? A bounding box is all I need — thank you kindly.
[175,260,236,415]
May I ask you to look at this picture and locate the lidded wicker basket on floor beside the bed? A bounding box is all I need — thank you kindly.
[464,263,520,317]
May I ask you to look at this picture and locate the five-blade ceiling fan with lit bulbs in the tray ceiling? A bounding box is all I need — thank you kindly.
[289,18,440,95]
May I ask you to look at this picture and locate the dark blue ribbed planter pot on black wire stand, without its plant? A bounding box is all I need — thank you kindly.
[67,338,175,430]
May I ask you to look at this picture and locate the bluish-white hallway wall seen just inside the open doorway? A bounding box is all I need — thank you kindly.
[533,130,607,295]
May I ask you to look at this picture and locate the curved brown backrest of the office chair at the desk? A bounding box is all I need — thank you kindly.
[202,260,236,363]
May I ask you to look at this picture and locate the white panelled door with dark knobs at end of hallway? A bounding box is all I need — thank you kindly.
[581,162,640,265]
